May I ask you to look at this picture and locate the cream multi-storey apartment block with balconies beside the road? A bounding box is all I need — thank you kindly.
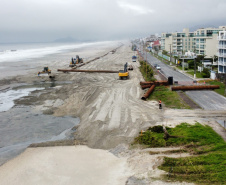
[161,26,226,58]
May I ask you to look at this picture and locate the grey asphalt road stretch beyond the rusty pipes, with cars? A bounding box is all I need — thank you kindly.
[147,53,193,82]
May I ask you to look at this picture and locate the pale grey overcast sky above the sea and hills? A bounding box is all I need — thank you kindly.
[0,0,226,43]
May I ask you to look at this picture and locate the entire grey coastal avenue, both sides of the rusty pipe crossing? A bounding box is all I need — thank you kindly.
[139,45,226,110]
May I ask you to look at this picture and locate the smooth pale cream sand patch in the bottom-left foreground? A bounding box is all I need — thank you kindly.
[0,146,131,185]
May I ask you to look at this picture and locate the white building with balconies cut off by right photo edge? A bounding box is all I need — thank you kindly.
[218,31,226,73]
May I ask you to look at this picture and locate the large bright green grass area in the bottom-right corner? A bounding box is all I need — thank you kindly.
[134,123,226,184]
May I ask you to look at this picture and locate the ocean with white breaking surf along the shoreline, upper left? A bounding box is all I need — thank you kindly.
[0,41,119,80]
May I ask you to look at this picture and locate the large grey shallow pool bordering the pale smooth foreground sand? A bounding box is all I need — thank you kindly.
[0,107,80,165]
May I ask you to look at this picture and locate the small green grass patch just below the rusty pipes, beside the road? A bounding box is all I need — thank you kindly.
[148,86,190,109]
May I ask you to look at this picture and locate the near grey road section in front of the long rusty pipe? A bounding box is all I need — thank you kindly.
[186,90,226,110]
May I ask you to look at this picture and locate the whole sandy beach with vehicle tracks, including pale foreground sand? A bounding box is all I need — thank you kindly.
[0,42,225,185]
